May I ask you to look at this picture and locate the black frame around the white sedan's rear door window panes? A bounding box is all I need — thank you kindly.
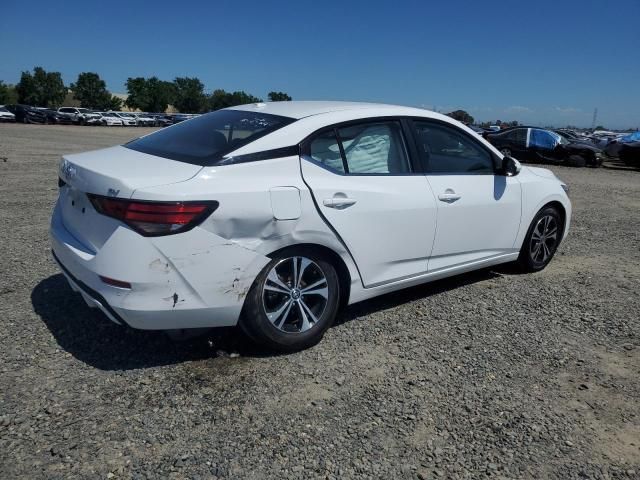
[299,115,424,177]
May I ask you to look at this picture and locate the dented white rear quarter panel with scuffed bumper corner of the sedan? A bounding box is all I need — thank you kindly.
[133,156,359,306]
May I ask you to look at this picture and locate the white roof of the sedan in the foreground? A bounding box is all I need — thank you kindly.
[228,100,440,119]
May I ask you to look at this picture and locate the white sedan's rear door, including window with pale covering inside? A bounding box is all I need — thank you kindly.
[301,120,436,287]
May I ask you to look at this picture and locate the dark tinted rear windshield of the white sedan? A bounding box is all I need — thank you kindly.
[124,110,294,166]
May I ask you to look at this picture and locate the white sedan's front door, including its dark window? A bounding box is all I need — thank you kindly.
[414,120,521,271]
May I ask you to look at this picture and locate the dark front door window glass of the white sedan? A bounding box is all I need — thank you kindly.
[415,121,494,175]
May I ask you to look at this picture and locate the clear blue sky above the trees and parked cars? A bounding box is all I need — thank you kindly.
[0,0,640,128]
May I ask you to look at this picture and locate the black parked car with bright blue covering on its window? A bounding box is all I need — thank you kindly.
[485,127,603,167]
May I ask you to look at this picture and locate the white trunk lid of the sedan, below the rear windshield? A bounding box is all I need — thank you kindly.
[58,146,202,252]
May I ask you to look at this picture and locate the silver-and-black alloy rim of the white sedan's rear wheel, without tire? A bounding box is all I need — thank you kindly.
[262,256,329,333]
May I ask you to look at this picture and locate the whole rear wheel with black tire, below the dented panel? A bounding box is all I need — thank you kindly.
[240,249,340,352]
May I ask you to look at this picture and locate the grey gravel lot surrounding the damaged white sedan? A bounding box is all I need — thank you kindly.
[0,125,640,479]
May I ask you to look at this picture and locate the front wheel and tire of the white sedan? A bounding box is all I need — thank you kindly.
[518,207,564,272]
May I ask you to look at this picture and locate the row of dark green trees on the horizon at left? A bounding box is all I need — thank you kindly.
[0,67,291,113]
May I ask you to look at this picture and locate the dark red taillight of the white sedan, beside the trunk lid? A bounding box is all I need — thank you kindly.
[87,194,218,237]
